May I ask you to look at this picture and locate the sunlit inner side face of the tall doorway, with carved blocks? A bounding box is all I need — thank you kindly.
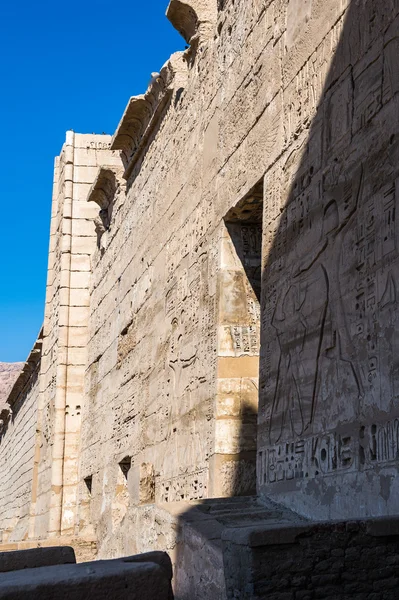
[210,222,259,496]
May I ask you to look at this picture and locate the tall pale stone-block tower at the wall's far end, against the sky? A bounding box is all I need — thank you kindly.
[31,132,119,537]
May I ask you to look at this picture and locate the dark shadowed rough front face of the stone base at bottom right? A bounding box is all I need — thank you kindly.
[222,518,399,600]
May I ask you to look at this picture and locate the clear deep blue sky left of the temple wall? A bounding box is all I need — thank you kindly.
[0,0,185,362]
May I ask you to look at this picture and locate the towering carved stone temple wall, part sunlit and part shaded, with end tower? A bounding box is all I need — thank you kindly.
[0,0,399,580]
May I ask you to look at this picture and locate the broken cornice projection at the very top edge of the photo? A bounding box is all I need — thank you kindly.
[166,0,217,44]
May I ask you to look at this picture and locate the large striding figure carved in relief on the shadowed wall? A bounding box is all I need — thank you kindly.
[269,166,364,444]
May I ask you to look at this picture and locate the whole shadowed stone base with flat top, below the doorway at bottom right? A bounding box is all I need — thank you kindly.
[168,497,399,600]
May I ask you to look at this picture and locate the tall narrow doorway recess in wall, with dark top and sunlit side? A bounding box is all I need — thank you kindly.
[216,180,263,496]
